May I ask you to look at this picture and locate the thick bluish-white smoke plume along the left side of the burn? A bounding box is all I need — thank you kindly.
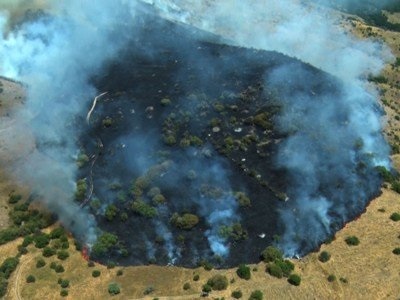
[0,0,141,243]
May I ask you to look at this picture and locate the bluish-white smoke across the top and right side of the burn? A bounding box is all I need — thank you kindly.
[147,0,391,255]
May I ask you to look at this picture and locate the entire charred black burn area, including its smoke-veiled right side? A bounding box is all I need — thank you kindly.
[65,8,380,266]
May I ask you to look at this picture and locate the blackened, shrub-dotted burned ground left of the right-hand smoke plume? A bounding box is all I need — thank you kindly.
[76,7,382,266]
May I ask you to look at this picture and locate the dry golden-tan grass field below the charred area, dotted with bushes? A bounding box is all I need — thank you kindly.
[0,184,400,300]
